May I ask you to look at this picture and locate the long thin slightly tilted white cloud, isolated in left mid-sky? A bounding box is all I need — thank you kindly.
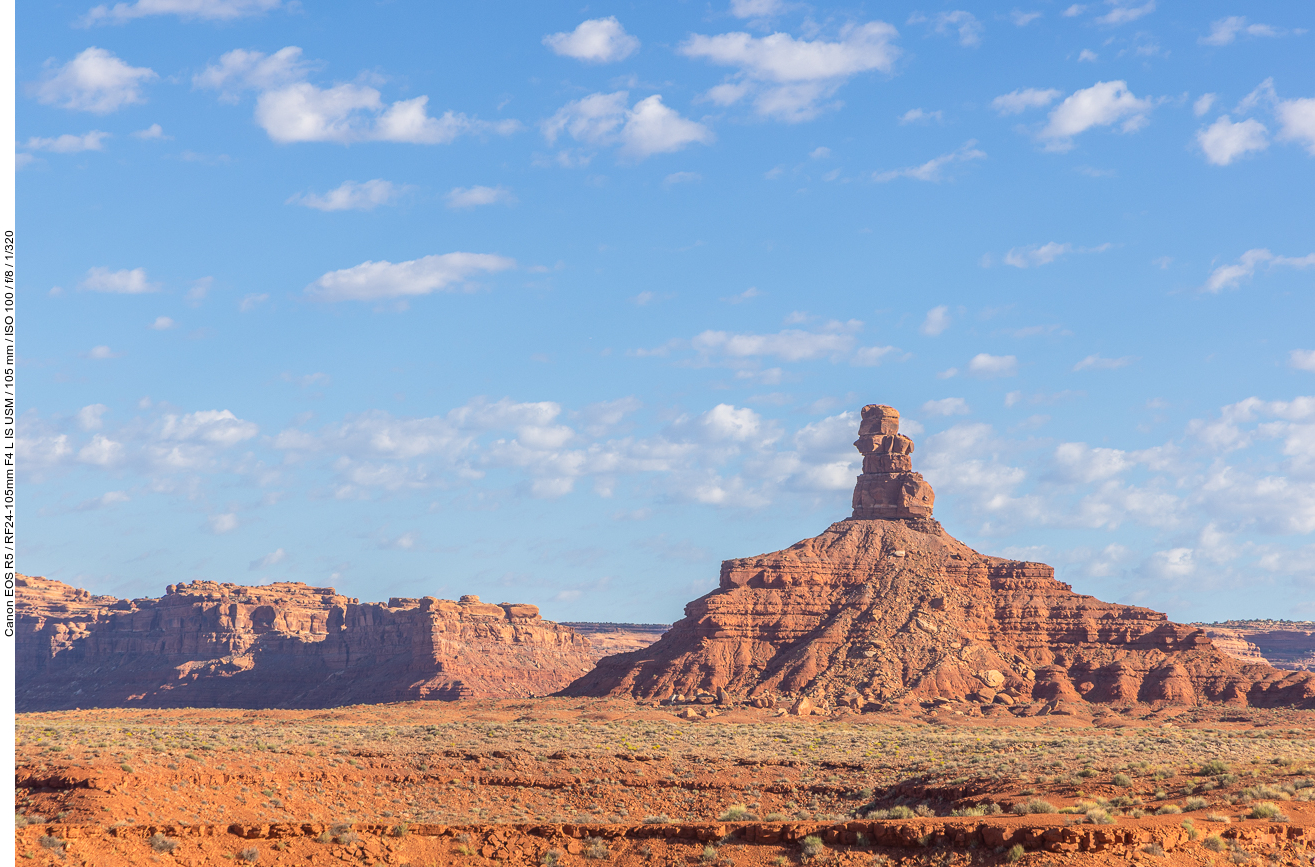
[306,253,515,301]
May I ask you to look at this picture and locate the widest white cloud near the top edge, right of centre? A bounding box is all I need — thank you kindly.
[679,21,899,124]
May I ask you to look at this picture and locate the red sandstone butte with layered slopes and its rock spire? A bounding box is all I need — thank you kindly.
[563,405,1315,716]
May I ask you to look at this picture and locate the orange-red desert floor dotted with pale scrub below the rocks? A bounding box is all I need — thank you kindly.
[16,699,1315,867]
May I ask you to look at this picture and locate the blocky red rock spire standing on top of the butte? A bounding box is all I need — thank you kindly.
[853,404,936,521]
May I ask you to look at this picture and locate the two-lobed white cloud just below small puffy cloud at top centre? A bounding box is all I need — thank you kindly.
[543,91,715,159]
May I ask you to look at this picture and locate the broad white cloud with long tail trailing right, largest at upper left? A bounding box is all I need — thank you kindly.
[192,46,521,145]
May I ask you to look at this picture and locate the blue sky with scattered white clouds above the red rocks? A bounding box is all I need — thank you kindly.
[17,0,1315,621]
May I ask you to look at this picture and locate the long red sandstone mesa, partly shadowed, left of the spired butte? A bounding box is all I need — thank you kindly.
[16,575,593,712]
